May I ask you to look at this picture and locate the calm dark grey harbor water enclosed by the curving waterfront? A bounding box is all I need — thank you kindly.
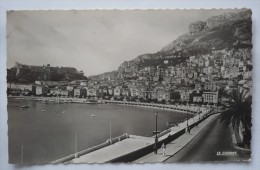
[8,99,192,164]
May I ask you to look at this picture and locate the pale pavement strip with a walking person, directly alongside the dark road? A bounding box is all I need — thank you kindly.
[134,114,218,163]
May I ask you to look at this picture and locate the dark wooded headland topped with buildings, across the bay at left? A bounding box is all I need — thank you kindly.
[7,62,86,83]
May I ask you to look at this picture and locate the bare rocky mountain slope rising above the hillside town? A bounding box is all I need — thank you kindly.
[90,10,252,80]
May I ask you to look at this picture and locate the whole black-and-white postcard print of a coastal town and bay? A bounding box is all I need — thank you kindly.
[6,8,253,164]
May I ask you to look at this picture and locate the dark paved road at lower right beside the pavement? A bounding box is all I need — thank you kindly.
[165,114,250,162]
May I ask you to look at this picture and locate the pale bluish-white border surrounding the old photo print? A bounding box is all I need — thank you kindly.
[0,0,260,170]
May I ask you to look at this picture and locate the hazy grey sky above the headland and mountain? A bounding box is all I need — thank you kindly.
[7,9,243,76]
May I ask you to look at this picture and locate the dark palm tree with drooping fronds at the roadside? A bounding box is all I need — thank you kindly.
[221,89,252,148]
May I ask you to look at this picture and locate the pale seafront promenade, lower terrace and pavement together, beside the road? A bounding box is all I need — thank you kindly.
[52,109,215,163]
